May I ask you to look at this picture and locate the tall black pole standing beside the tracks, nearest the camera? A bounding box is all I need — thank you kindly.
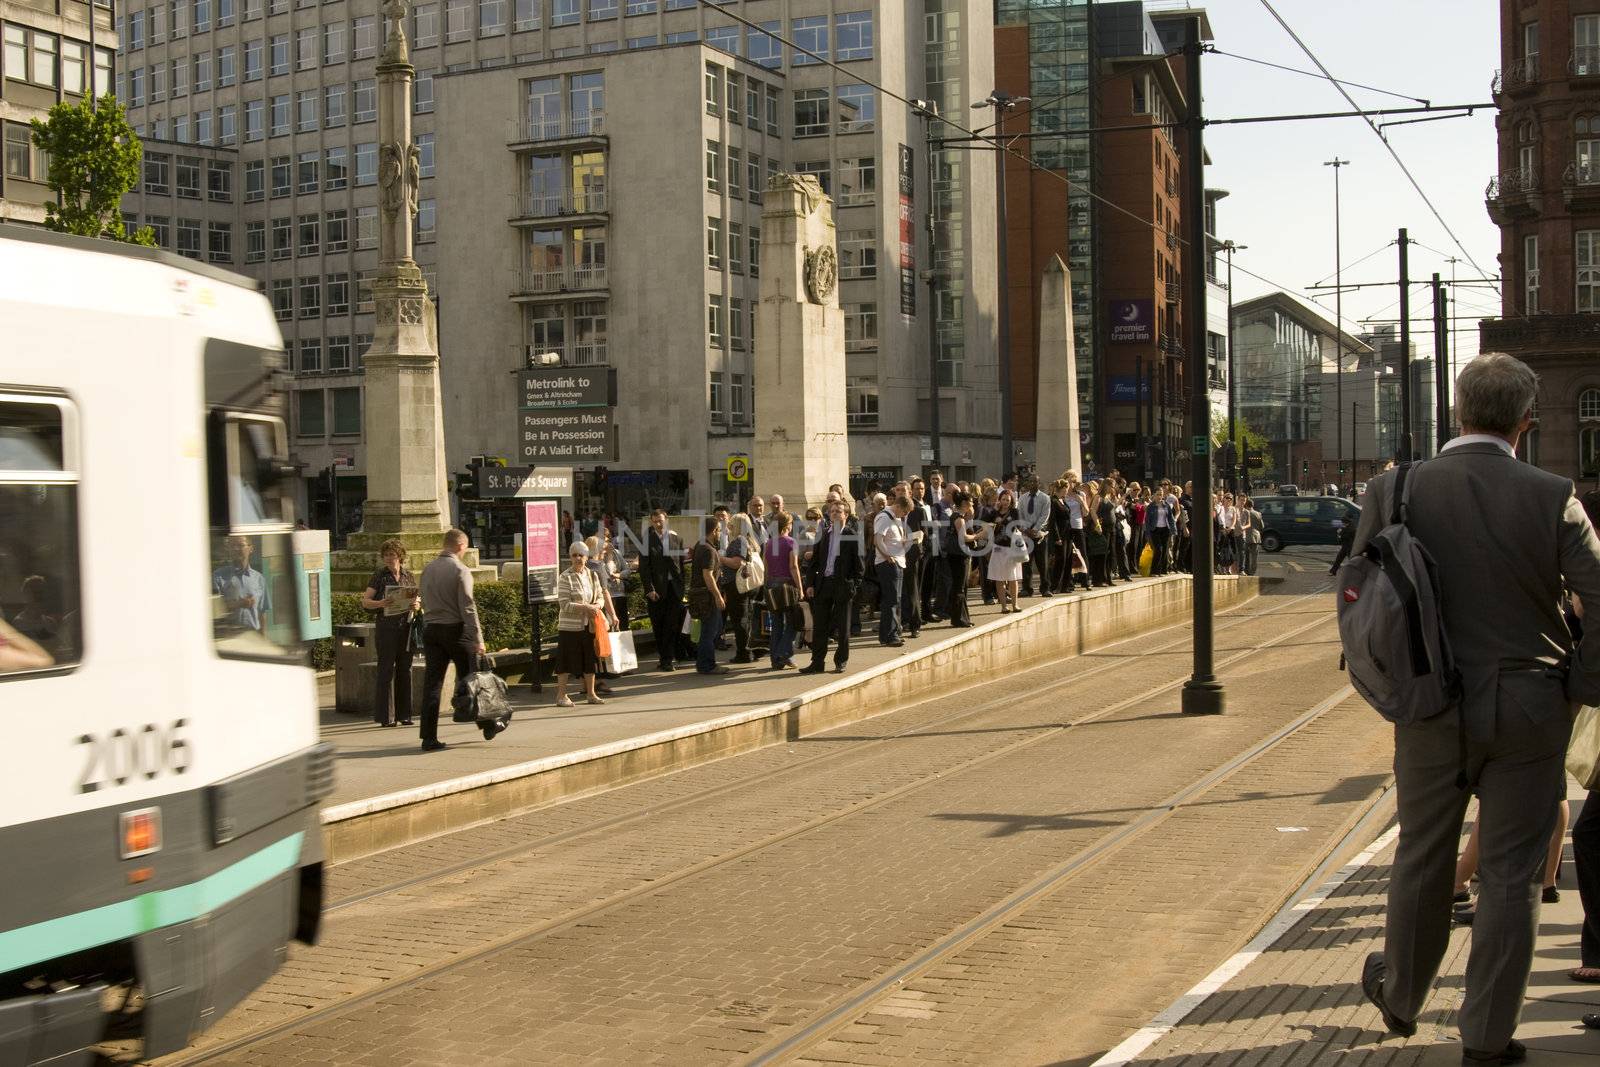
[1182,14,1224,715]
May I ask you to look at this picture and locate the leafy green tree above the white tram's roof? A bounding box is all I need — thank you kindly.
[32,94,155,245]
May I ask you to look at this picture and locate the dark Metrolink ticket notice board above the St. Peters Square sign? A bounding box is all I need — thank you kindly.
[517,366,616,467]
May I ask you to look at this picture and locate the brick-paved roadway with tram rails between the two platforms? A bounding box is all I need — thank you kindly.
[118,558,1387,1065]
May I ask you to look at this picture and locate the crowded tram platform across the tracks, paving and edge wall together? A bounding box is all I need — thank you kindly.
[320,574,1258,859]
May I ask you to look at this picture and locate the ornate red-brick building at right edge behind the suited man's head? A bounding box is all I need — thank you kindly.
[1480,0,1600,480]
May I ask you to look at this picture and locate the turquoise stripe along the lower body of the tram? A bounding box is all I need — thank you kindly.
[0,832,306,973]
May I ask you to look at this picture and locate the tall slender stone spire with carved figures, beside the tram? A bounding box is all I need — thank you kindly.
[324,0,451,592]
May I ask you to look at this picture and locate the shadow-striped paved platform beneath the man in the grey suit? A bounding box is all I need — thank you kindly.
[1091,779,1600,1067]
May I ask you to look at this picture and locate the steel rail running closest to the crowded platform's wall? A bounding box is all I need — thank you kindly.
[323,585,1326,920]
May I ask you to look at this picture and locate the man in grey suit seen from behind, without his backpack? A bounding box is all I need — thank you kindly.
[1354,354,1600,1067]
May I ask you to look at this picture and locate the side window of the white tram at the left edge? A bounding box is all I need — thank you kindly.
[0,394,83,677]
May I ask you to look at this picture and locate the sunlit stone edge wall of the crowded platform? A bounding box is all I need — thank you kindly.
[322,576,1258,862]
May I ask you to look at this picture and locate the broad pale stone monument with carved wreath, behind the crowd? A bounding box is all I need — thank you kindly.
[750,174,850,515]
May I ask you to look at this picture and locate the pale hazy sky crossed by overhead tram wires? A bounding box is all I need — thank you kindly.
[1177,0,1499,358]
